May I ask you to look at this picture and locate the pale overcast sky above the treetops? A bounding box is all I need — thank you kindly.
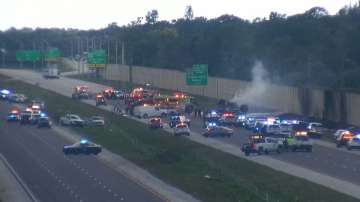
[0,0,357,30]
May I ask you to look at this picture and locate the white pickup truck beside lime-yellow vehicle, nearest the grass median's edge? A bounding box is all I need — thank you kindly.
[241,137,284,156]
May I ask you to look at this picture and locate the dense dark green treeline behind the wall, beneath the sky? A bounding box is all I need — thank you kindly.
[0,3,360,89]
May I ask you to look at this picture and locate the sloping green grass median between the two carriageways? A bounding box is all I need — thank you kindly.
[0,77,358,202]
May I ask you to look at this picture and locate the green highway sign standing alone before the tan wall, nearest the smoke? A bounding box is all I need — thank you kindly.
[186,64,208,86]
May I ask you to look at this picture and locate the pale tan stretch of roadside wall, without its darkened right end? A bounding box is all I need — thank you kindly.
[105,64,301,113]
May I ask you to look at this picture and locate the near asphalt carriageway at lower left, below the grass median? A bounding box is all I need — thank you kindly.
[0,101,162,202]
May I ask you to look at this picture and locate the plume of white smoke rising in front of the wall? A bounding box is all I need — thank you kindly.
[231,61,270,106]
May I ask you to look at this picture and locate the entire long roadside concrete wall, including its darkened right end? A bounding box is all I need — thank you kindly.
[68,61,360,125]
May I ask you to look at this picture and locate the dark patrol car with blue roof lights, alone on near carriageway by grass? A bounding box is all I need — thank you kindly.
[63,140,102,155]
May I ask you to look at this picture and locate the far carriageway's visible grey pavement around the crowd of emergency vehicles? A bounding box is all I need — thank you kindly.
[2,70,360,197]
